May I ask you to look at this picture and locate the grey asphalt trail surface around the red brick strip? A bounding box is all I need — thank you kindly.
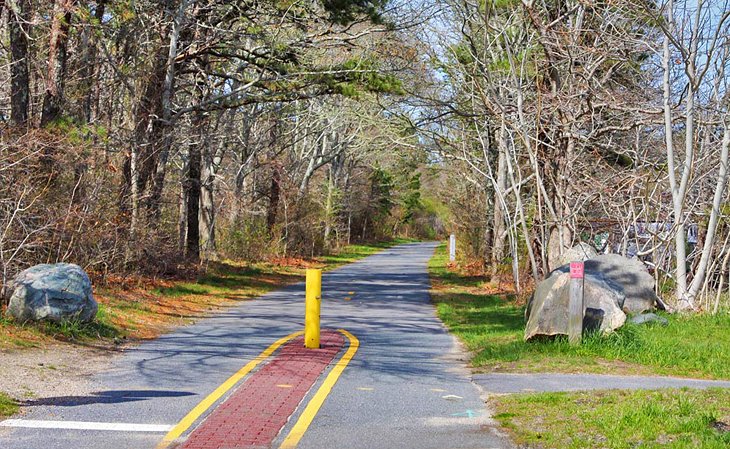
[0,243,511,449]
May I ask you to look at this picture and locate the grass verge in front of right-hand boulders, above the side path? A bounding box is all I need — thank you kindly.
[429,245,730,379]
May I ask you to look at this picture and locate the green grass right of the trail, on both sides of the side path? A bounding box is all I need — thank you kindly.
[429,244,730,449]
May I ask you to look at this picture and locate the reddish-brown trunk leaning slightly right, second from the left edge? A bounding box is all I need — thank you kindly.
[41,0,75,127]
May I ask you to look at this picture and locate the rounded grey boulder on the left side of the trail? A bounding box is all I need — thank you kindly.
[8,263,98,322]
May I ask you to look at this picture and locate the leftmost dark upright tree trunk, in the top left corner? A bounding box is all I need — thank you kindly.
[8,0,31,126]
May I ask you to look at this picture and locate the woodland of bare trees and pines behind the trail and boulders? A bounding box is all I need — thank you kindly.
[0,0,730,312]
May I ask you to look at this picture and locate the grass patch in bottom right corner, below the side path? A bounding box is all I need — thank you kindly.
[490,389,730,449]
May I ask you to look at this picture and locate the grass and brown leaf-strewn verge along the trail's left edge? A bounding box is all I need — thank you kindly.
[0,239,412,349]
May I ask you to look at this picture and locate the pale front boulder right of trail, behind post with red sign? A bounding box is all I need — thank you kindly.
[525,266,626,340]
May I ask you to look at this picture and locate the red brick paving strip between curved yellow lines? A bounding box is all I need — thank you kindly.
[180,331,345,449]
